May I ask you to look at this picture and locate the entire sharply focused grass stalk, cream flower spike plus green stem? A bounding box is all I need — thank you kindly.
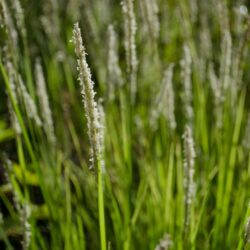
[73,23,107,250]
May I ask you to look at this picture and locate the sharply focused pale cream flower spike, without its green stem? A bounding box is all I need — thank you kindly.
[72,23,103,172]
